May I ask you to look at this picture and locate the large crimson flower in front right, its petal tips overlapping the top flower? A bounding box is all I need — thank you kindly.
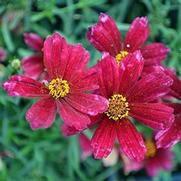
[91,51,174,160]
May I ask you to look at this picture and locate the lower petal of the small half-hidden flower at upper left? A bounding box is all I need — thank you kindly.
[21,55,44,79]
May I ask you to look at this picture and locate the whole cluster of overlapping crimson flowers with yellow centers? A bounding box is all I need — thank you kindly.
[3,13,181,176]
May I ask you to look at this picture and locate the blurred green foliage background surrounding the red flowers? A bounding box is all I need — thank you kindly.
[0,0,181,181]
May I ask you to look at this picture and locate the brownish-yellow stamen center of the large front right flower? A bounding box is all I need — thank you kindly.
[105,94,130,121]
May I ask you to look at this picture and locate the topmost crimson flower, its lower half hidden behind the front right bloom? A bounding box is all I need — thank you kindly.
[87,13,169,65]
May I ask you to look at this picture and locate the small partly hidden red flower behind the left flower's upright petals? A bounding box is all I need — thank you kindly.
[21,33,45,79]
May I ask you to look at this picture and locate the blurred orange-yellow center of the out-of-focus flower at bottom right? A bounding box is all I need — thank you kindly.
[145,139,157,158]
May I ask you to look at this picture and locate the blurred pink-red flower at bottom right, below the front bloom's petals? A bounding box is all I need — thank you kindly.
[122,139,174,177]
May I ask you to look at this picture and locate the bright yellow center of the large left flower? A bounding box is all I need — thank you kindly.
[48,78,70,99]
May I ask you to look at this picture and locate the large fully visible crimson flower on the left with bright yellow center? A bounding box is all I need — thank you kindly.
[3,33,108,130]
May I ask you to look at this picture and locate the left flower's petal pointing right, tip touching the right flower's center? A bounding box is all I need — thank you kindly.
[65,93,108,116]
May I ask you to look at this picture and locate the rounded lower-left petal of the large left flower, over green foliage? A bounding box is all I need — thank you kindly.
[26,98,57,129]
